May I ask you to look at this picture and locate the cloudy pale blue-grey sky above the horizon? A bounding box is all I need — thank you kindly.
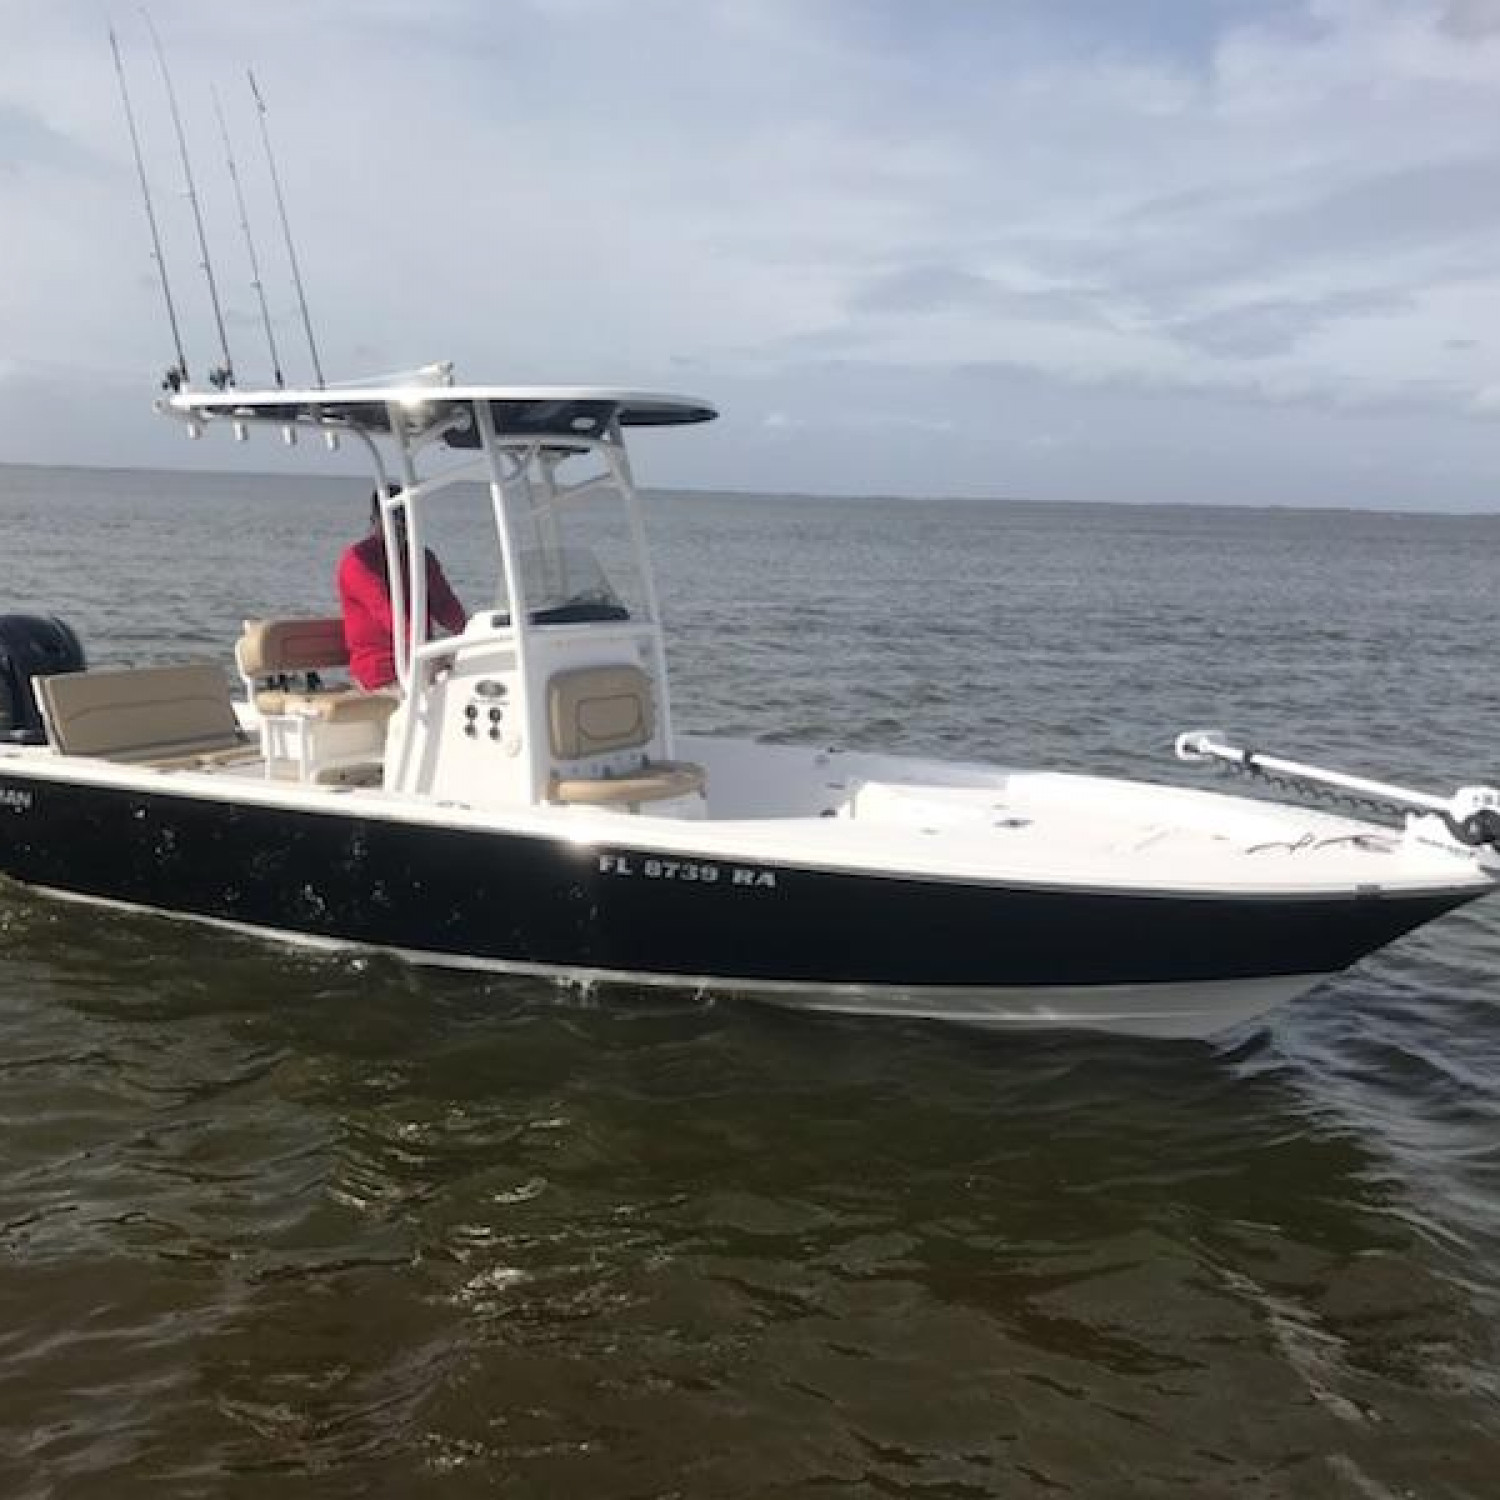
[0,0,1500,512]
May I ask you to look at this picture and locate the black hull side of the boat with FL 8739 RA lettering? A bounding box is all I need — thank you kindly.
[0,776,1481,990]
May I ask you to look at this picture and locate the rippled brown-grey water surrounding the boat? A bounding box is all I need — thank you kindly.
[0,468,1500,1500]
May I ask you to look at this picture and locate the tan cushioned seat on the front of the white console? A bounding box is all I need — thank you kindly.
[548,665,707,807]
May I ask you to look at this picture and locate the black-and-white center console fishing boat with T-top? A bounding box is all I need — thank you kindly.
[0,366,1500,1037]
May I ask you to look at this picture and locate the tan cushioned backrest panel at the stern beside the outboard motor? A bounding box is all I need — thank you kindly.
[35,663,252,765]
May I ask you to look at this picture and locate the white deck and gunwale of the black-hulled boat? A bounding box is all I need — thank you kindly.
[0,735,1493,897]
